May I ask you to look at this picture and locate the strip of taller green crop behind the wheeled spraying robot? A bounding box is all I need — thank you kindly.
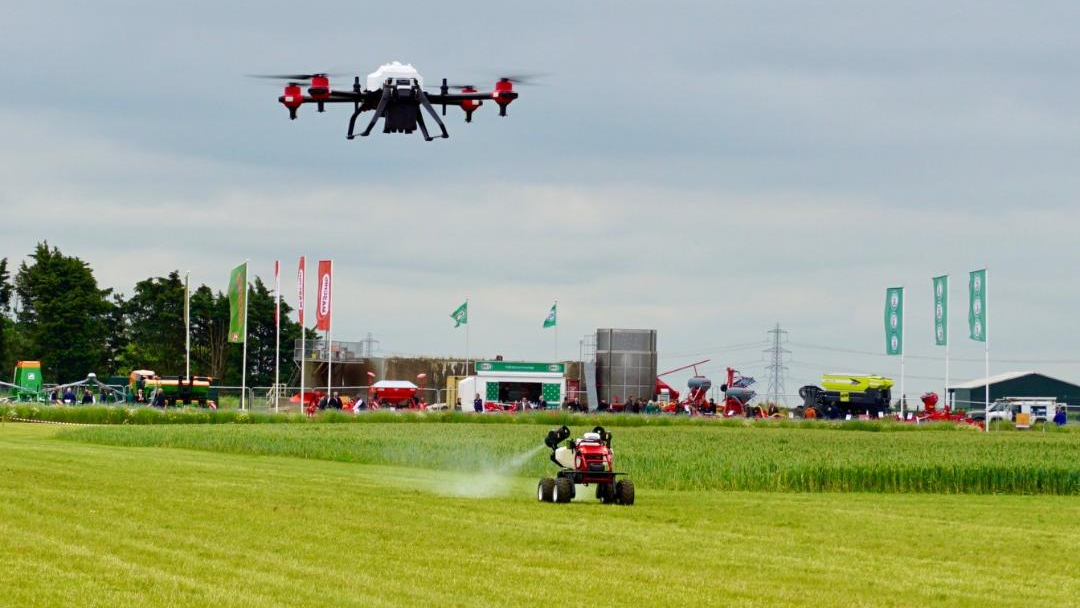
[62,422,1080,495]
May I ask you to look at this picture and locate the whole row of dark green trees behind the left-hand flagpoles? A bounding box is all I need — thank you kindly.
[0,242,306,386]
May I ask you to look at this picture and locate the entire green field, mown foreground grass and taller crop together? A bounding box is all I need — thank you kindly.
[0,422,1080,608]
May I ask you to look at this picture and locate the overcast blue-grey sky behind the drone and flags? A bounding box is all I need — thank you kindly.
[0,0,1080,393]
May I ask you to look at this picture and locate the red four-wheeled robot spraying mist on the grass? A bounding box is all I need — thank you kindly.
[537,427,634,505]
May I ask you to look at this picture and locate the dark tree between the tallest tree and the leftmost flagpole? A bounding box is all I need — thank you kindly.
[121,270,185,376]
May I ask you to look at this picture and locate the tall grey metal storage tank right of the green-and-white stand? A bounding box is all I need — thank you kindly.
[596,328,657,403]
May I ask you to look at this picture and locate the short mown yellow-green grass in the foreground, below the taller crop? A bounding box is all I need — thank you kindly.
[0,422,1080,608]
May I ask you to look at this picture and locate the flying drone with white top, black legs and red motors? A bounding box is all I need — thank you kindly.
[249,62,524,141]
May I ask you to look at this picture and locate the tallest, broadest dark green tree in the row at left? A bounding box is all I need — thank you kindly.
[15,242,111,382]
